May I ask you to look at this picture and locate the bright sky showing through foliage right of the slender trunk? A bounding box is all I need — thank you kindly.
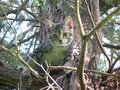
[98,8,120,71]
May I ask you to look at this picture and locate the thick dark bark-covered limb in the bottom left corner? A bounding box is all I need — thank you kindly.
[0,66,44,90]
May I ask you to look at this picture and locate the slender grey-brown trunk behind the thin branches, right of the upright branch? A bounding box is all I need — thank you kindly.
[88,0,102,70]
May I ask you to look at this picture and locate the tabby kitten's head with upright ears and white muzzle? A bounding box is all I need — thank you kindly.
[45,16,73,46]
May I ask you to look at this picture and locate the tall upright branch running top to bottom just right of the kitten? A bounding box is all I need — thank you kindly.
[75,0,88,90]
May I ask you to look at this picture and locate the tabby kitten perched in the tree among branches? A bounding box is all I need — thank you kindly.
[23,16,73,76]
